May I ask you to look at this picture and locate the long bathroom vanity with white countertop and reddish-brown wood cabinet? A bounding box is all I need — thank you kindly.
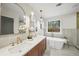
[0,36,46,56]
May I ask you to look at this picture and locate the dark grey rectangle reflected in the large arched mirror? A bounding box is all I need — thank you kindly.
[0,16,14,35]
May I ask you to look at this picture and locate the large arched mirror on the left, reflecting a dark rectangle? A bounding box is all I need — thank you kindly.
[0,3,26,35]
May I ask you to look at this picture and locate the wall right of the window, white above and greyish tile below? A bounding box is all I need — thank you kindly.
[61,13,77,45]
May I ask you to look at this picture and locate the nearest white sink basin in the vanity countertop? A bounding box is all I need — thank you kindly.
[8,42,29,54]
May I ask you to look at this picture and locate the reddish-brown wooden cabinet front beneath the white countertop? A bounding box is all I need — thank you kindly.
[24,38,46,56]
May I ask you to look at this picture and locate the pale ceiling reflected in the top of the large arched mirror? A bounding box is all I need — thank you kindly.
[1,3,24,20]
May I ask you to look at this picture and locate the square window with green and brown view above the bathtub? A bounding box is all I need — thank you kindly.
[48,20,60,32]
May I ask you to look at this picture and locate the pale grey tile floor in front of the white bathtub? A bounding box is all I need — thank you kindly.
[44,45,79,56]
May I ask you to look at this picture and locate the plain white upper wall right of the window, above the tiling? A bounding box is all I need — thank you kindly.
[60,13,76,29]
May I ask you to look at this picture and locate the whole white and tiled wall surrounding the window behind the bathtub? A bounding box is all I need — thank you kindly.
[44,13,77,45]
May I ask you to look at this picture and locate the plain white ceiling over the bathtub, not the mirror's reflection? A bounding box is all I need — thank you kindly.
[29,3,79,18]
